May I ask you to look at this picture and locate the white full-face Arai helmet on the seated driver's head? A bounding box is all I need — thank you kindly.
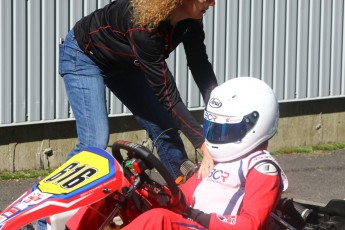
[204,77,279,162]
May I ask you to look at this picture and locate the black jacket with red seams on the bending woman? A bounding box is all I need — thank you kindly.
[74,0,217,147]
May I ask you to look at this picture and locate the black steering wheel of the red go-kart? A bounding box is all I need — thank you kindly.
[112,140,183,206]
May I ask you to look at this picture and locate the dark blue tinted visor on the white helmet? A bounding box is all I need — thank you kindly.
[204,111,258,144]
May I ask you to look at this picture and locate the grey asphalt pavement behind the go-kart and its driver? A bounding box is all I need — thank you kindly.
[0,150,345,210]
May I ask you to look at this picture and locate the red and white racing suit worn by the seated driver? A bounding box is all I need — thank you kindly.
[124,151,288,230]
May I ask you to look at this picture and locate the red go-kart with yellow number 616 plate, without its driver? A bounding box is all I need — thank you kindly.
[0,140,345,230]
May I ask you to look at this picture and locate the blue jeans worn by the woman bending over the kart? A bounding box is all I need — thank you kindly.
[59,30,187,179]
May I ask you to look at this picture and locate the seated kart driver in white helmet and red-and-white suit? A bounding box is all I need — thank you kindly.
[123,77,288,230]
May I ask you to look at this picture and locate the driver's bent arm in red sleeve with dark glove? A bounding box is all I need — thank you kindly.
[181,165,281,230]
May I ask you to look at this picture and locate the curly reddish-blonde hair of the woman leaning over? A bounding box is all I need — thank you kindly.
[130,0,183,28]
